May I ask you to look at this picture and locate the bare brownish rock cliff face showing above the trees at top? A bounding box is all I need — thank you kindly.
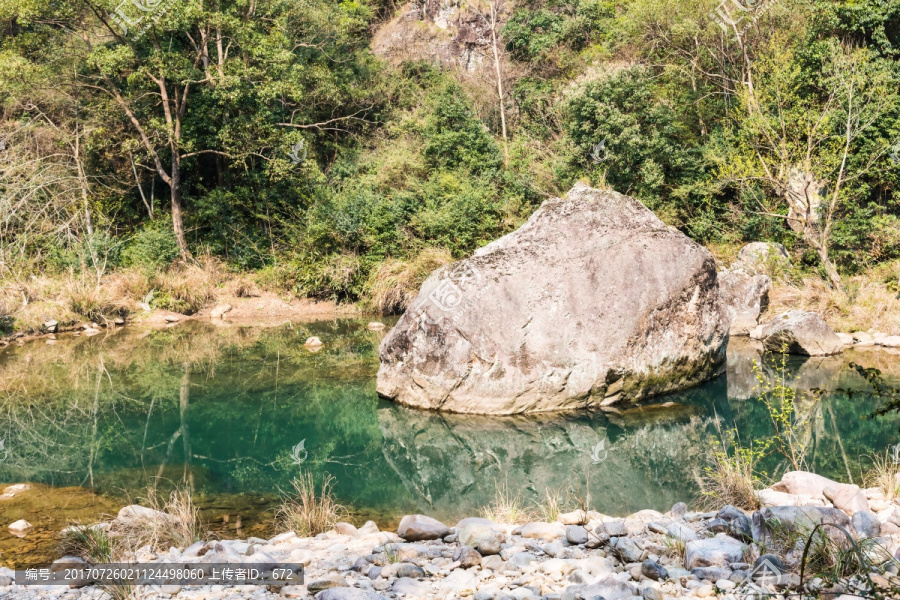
[372,0,508,72]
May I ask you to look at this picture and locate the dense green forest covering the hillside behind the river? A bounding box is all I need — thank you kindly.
[0,0,900,328]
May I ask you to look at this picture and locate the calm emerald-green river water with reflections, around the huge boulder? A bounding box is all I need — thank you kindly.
[0,319,900,563]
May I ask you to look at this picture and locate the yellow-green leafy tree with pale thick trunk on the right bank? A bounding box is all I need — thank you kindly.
[720,41,897,290]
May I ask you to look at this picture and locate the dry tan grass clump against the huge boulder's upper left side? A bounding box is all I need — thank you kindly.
[366,248,453,315]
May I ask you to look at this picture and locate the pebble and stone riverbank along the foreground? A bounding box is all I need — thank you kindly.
[0,472,900,600]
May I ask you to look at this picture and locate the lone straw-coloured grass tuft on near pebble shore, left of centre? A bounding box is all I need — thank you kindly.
[277,473,349,537]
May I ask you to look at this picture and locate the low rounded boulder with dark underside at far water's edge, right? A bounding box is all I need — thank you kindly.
[759,310,844,356]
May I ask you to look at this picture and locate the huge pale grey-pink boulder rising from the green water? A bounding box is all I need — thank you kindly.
[377,184,728,414]
